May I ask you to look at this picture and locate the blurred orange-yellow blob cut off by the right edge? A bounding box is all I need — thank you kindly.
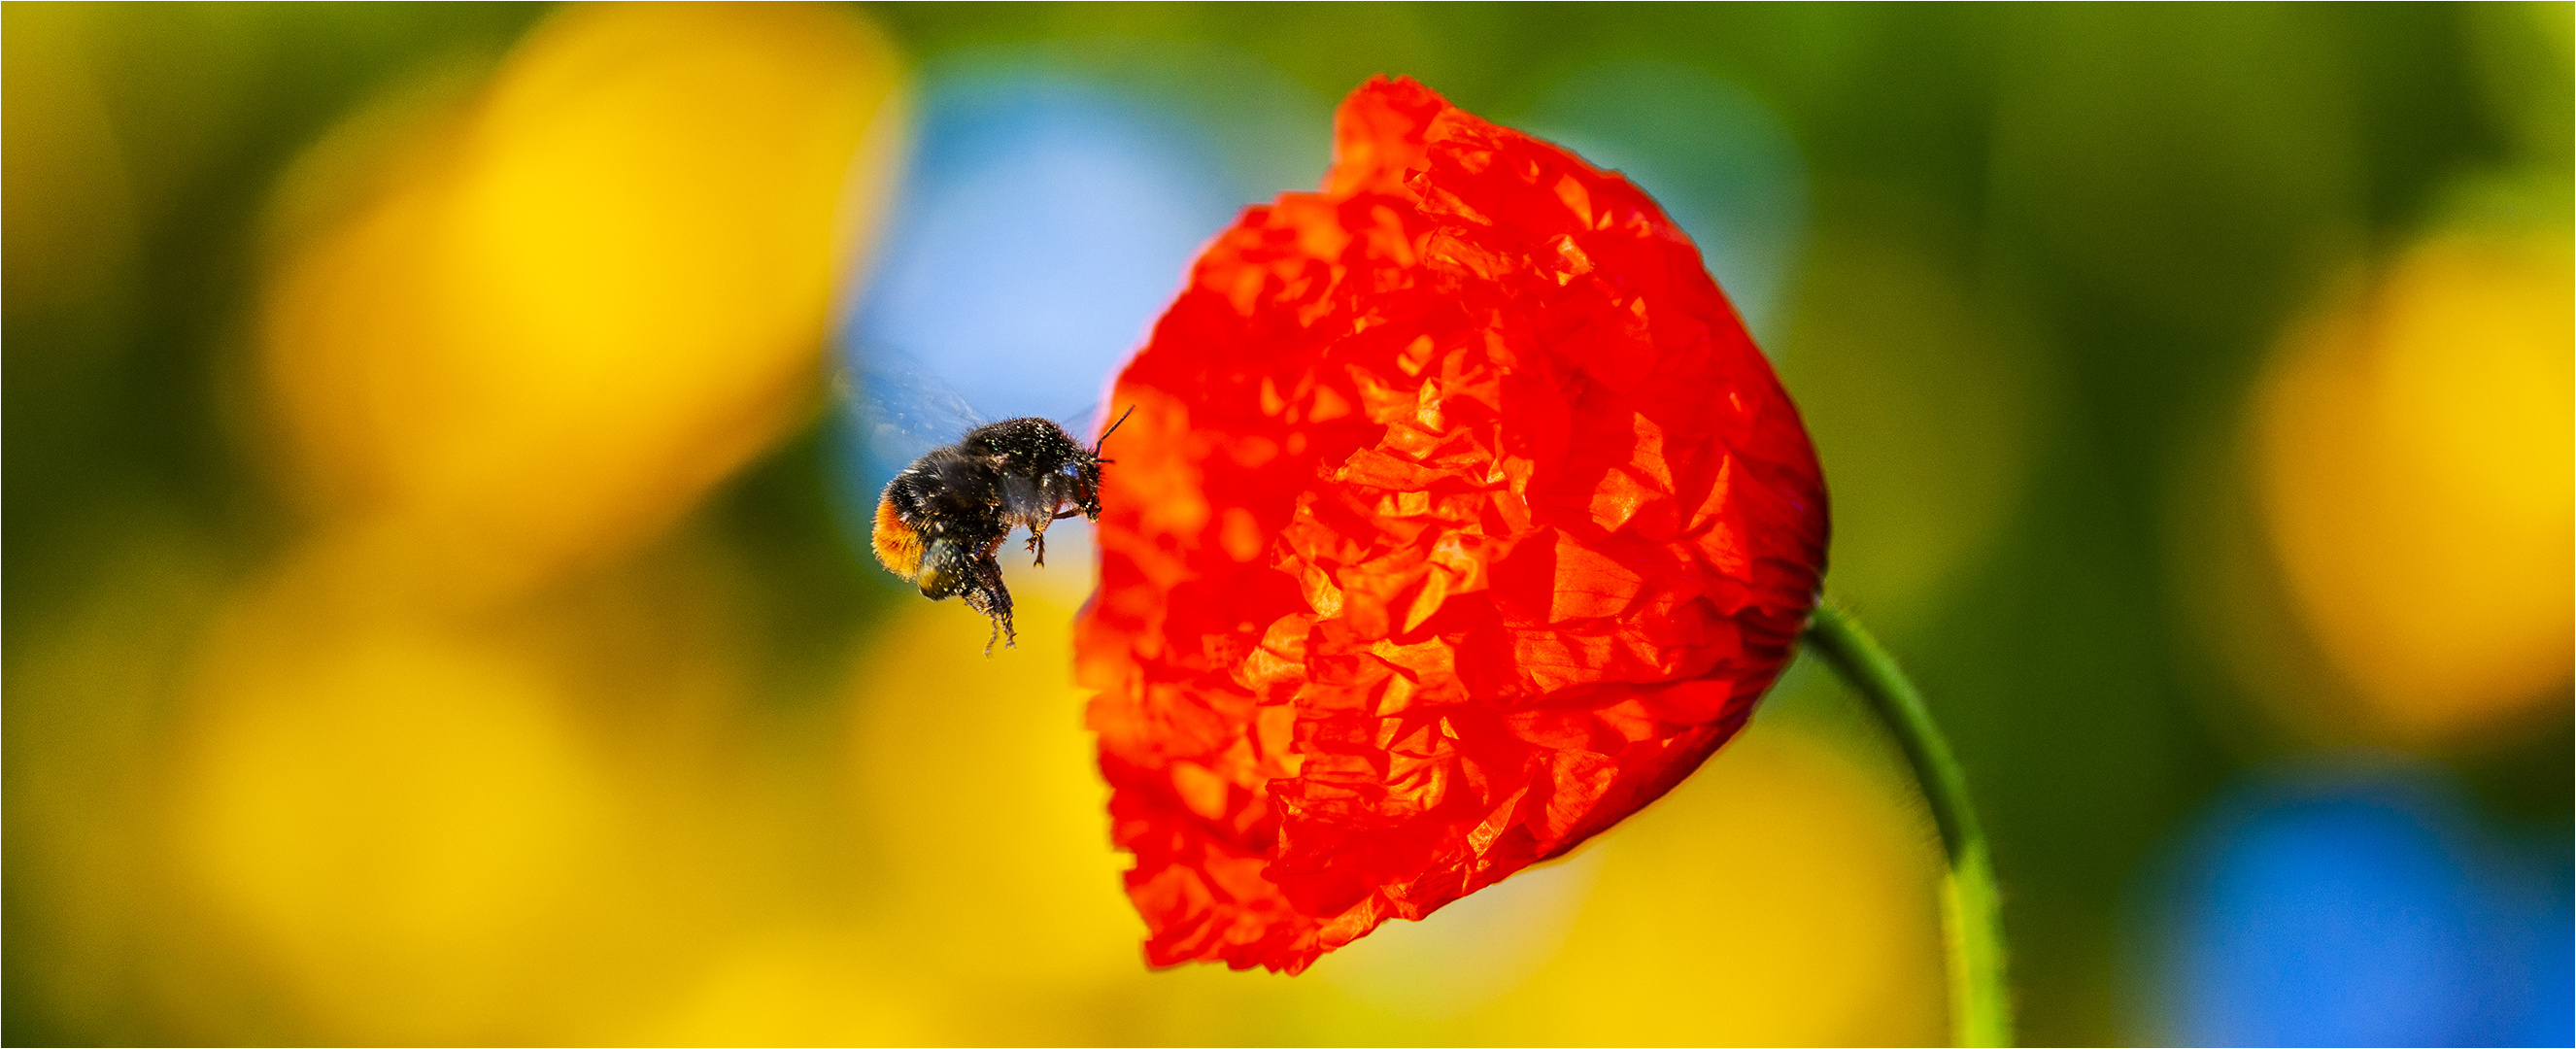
[2256,229,2576,742]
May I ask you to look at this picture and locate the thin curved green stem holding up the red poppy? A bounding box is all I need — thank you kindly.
[1806,606,2012,1046]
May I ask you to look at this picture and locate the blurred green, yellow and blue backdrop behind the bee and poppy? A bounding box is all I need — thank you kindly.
[0,3,2576,1044]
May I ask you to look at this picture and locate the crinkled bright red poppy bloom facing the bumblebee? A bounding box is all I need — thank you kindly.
[1077,80,1826,971]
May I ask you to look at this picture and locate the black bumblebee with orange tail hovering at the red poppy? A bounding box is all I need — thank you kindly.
[870,407,1134,655]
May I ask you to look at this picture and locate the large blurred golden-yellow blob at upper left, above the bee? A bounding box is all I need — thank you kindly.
[260,5,901,600]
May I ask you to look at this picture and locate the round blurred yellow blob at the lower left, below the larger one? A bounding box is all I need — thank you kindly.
[181,608,616,1041]
